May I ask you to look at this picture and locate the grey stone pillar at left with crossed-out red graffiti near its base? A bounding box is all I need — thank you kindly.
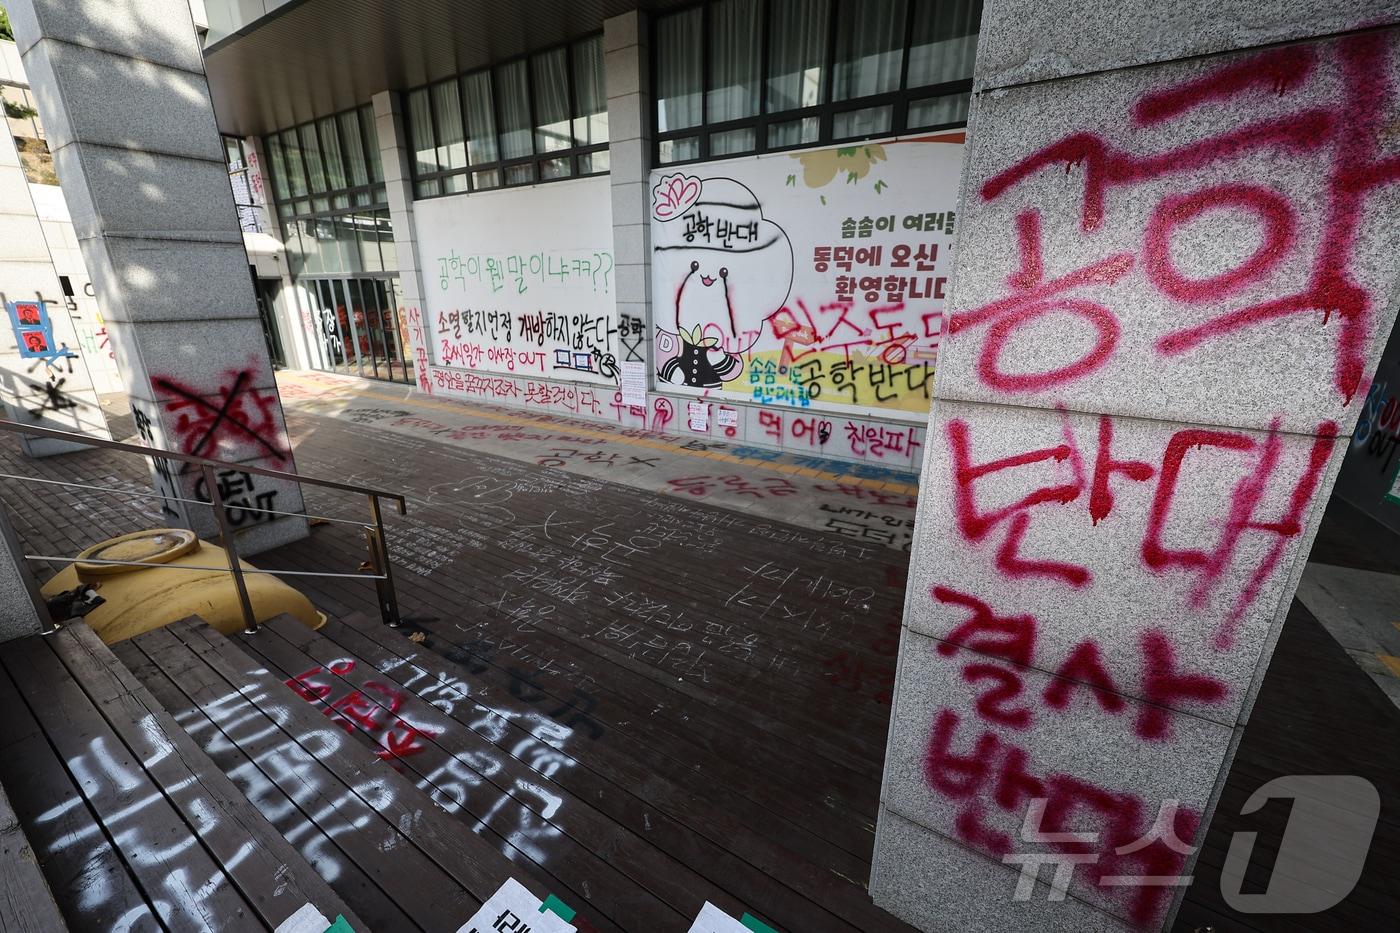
[7,0,307,553]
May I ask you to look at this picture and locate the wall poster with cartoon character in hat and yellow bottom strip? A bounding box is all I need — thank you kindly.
[650,132,965,417]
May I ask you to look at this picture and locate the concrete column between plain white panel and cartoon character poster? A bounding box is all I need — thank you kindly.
[603,10,652,380]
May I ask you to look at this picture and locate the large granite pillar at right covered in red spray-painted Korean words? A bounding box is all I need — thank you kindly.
[871,7,1400,930]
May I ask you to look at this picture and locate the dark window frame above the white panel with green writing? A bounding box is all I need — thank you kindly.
[403,32,612,200]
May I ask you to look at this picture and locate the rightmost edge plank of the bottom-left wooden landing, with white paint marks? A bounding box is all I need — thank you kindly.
[49,625,358,929]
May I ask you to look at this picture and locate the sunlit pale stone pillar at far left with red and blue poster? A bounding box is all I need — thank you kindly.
[0,118,112,457]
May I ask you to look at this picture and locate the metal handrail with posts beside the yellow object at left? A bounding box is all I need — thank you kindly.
[0,419,407,635]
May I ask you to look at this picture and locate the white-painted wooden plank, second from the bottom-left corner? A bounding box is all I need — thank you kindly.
[0,652,161,933]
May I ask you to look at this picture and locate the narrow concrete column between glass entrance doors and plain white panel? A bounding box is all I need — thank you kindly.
[370,91,433,392]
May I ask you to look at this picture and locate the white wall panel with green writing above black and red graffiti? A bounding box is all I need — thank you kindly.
[413,177,620,385]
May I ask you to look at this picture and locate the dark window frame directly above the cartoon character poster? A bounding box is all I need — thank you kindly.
[648,0,980,168]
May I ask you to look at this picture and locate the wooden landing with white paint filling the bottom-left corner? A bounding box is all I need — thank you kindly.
[0,623,355,933]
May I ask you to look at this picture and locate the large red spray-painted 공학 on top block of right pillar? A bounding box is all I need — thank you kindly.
[968,34,1400,403]
